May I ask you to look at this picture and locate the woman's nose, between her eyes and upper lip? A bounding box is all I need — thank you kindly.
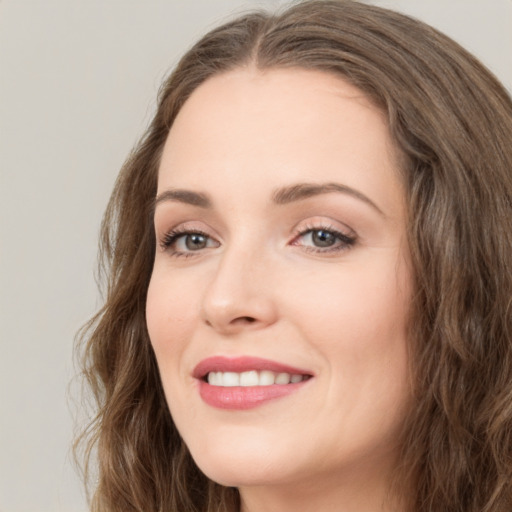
[202,244,277,335]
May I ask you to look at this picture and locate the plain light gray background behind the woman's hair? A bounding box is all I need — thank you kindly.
[0,0,512,512]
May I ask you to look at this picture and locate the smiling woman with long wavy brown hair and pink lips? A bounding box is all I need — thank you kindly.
[76,0,512,512]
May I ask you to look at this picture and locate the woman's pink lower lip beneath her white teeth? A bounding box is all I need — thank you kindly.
[199,379,310,410]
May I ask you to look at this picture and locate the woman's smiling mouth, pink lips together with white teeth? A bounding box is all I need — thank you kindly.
[193,356,313,410]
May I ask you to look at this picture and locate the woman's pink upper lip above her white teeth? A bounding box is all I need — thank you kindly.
[192,356,312,379]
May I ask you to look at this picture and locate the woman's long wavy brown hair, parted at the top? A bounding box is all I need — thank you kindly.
[77,0,512,512]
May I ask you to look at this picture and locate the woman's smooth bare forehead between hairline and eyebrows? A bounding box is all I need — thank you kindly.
[159,68,401,214]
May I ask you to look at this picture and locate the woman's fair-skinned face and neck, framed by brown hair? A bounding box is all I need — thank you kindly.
[147,67,411,512]
